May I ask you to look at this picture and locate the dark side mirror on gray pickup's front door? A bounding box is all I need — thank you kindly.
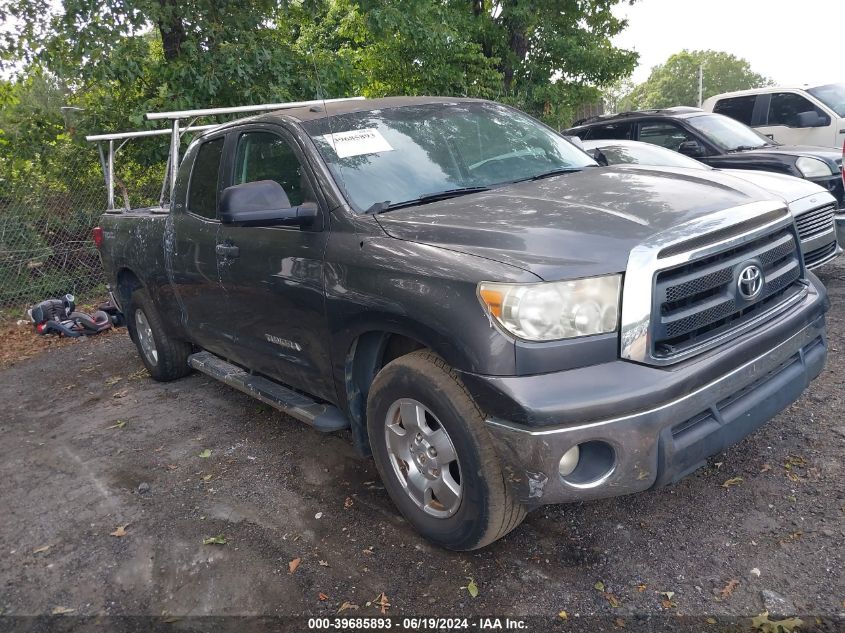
[220,180,319,226]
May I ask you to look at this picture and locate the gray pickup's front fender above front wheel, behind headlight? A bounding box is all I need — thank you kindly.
[325,237,537,382]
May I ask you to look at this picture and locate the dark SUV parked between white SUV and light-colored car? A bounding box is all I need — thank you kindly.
[564,107,845,209]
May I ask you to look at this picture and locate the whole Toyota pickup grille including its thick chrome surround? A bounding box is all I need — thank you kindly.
[619,200,809,365]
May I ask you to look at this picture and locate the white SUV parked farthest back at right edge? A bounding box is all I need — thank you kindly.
[702,83,845,148]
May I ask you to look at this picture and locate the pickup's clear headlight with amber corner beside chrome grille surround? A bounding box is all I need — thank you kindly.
[478,275,622,341]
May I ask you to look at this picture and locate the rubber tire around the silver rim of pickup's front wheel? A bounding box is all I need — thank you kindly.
[367,350,525,550]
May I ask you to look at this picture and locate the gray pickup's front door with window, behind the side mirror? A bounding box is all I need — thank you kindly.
[217,125,336,400]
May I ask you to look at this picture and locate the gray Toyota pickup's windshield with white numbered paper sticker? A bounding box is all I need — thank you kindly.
[304,102,596,212]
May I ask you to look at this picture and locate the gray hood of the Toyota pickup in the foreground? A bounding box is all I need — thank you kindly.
[376,165,775,280]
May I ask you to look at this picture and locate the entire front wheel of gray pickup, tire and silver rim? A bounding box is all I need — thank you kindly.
[367,350,525,551]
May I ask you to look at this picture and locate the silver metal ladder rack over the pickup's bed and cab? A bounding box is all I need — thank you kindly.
[85,97,364,211]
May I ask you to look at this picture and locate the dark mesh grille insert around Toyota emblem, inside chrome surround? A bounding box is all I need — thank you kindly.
[651,227,804,359]
